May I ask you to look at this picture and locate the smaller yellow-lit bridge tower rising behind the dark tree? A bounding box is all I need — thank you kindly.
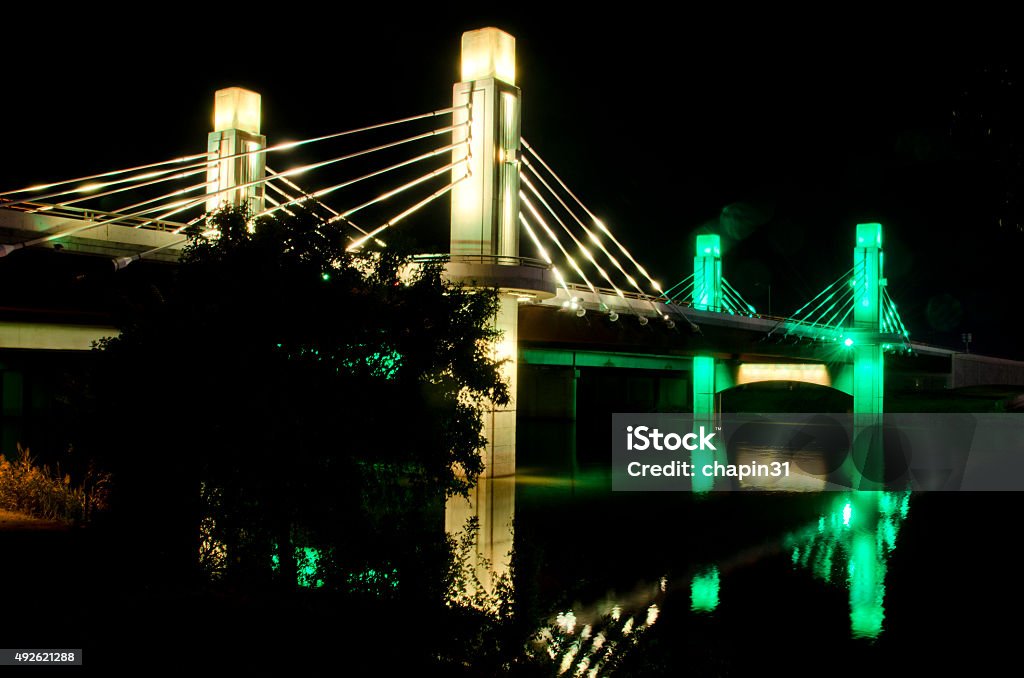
[206,87,266,214]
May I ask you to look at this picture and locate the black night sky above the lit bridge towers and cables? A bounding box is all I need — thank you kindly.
[0,11,1024,358]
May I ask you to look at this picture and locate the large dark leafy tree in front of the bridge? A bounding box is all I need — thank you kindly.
[93,205,508,599]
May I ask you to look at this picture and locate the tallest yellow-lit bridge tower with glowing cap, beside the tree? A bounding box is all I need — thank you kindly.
[446,28,555,476]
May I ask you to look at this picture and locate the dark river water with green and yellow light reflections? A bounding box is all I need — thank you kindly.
[449,420,1022,676]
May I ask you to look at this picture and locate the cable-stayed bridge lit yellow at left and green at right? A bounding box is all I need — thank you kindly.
[0,29,1024,483]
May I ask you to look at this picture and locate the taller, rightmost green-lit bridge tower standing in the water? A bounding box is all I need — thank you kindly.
[847,223,886,490]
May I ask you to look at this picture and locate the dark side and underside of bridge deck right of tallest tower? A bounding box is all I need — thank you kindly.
[519,304,1024,394]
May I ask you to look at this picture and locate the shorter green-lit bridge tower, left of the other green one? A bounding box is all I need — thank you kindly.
[692,235,722,492]
